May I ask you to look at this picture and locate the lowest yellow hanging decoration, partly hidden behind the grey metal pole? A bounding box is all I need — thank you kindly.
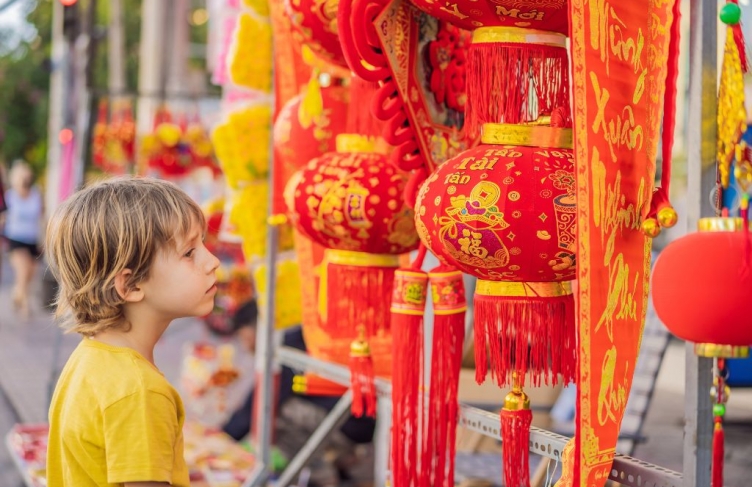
[253,260,303,329]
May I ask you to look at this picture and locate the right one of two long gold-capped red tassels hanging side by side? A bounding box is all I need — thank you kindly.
[421,266,467,487]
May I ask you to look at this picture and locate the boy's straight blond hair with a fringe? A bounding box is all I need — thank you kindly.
[46,178,206,336]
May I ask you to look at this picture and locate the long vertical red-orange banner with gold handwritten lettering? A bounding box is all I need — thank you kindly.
[558,0,675,487]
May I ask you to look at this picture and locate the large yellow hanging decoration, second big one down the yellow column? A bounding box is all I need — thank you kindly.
[212,105,272,189]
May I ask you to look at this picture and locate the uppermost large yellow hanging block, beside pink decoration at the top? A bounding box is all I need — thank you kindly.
[229,13,272,93]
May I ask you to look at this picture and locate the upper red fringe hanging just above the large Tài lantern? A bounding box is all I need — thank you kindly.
[465,42,572,139]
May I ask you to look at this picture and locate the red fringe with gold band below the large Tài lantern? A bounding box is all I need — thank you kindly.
[475,281,577,387]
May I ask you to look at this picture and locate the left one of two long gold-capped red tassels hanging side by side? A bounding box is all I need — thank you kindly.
[391,250,428,487]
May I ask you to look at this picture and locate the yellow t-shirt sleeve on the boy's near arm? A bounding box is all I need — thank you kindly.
[104,390,180,484]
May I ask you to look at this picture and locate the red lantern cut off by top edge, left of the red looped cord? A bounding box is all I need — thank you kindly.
[285,0,347,68]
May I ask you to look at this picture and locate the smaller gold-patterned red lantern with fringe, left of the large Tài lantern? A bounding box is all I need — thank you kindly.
[285,134,419,416]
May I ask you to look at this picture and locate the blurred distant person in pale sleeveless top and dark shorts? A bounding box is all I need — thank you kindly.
[0,161,44,318]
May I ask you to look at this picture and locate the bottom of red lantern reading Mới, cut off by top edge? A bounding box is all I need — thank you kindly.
[411,0,569,34]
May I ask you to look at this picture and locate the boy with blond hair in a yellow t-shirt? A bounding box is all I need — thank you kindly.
[46,178,219,487]
